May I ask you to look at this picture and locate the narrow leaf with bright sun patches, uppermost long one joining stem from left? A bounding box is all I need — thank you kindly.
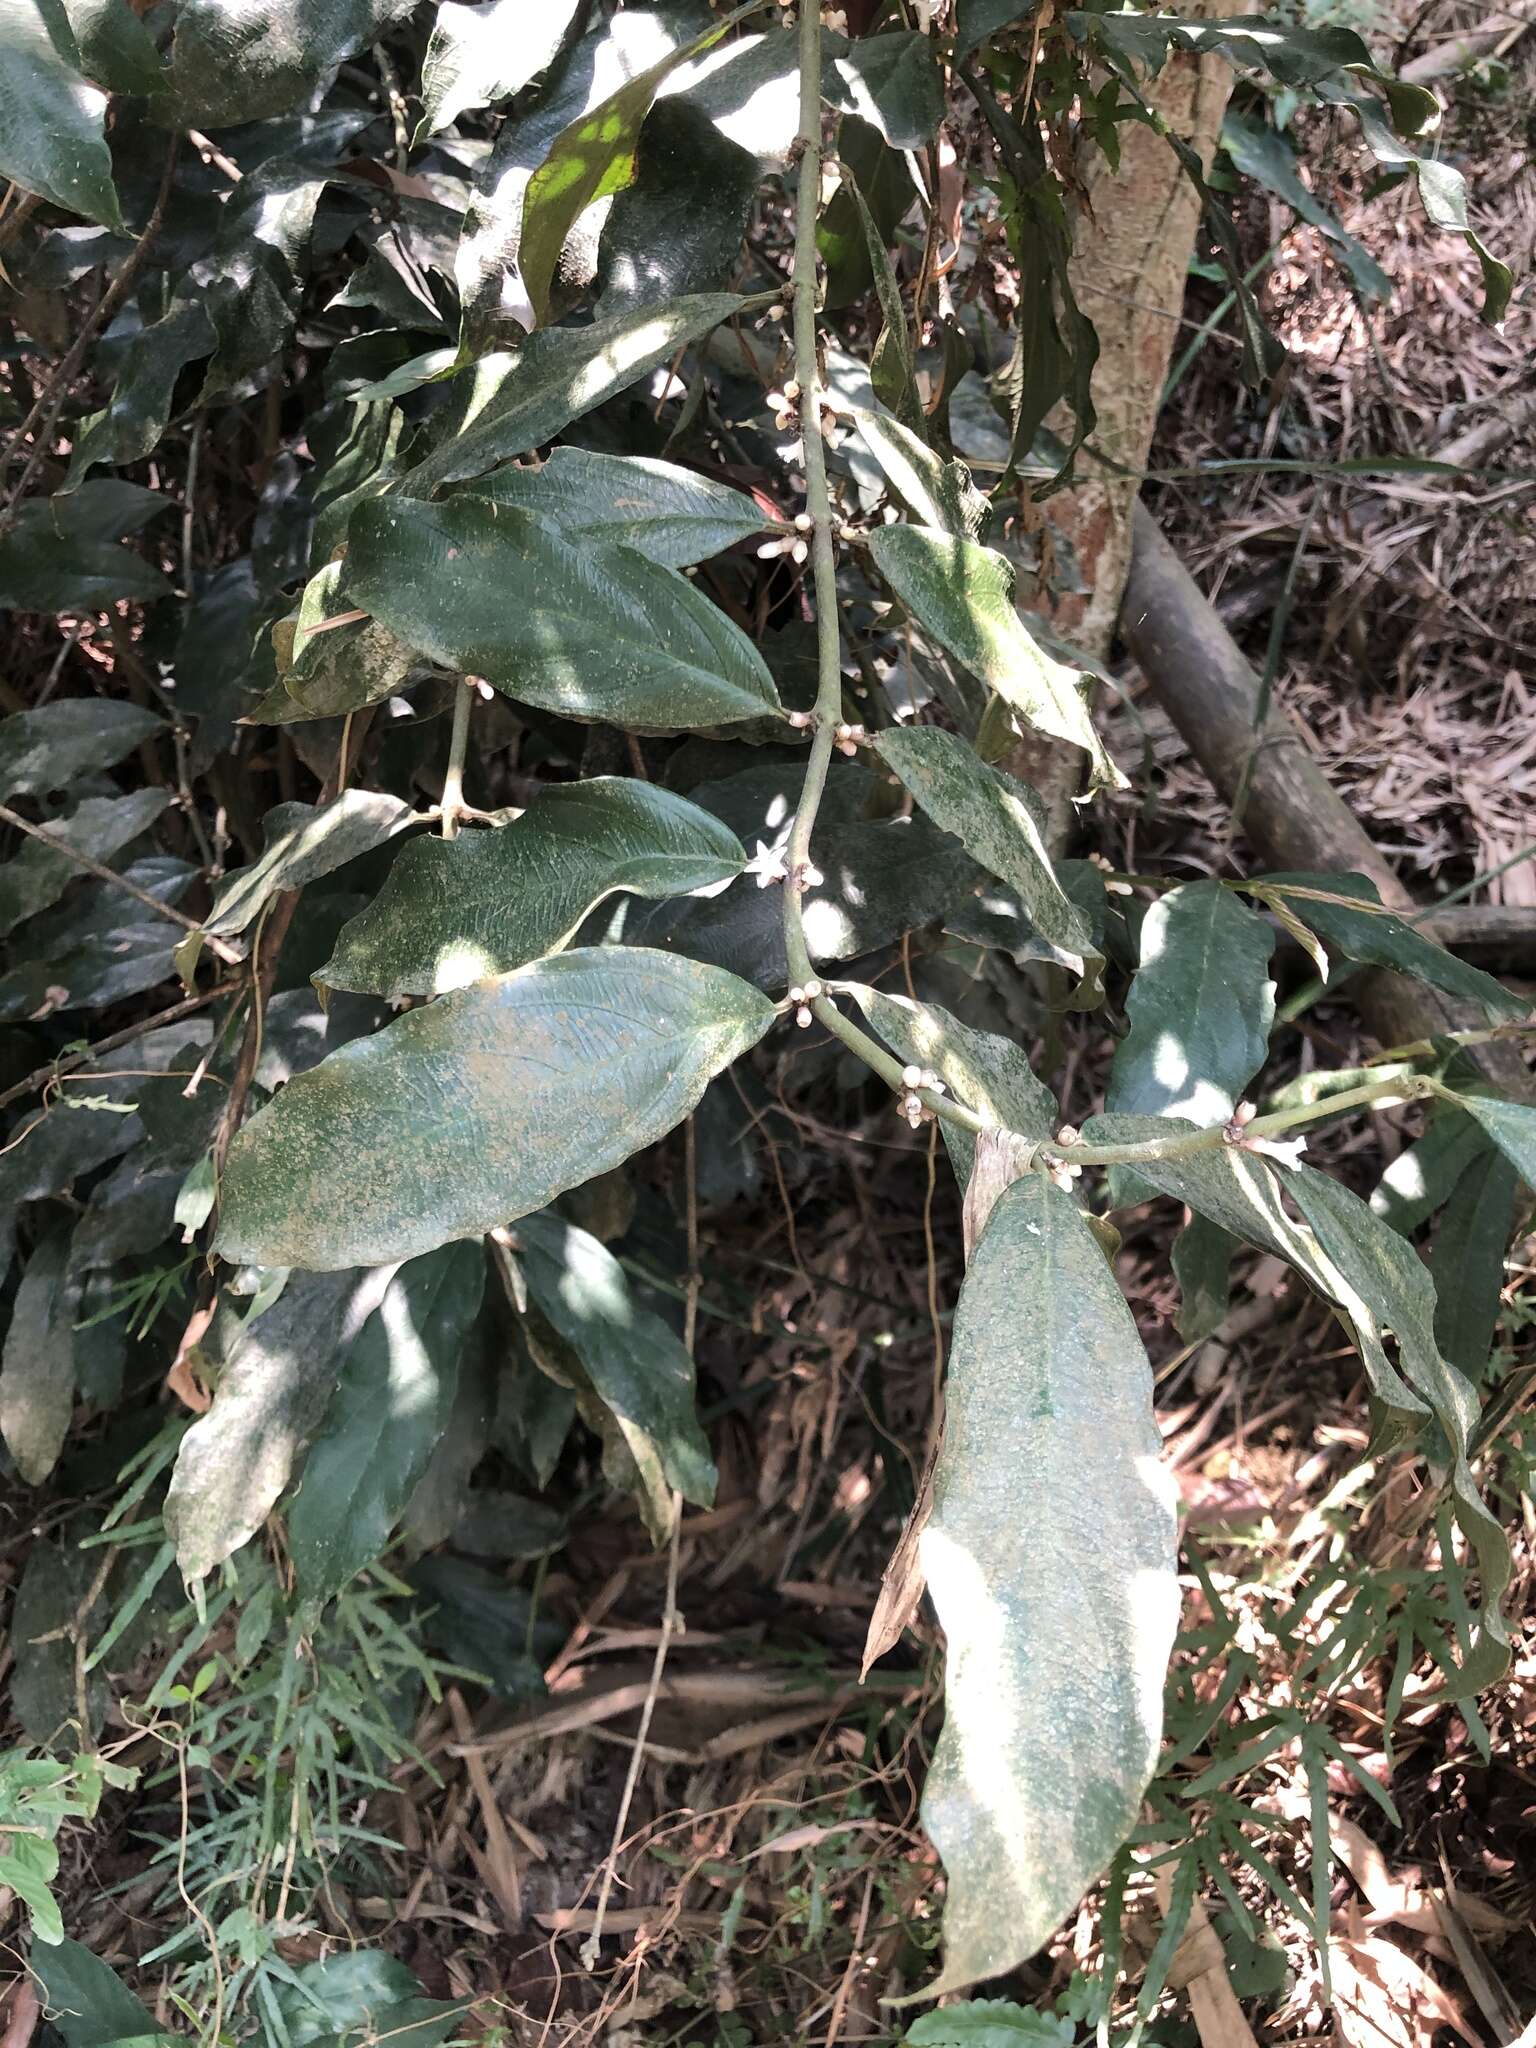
[406,291,743,498]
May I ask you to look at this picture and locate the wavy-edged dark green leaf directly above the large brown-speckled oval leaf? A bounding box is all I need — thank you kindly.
[315,776,745,1001]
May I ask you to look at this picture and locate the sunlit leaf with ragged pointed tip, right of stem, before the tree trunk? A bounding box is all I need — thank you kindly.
[870,526,1124,788]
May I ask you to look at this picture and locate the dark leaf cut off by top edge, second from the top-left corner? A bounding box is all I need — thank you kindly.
[170,0,412,127]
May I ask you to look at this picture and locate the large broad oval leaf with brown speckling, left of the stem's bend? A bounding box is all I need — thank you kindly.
[217,948,774,1268]
